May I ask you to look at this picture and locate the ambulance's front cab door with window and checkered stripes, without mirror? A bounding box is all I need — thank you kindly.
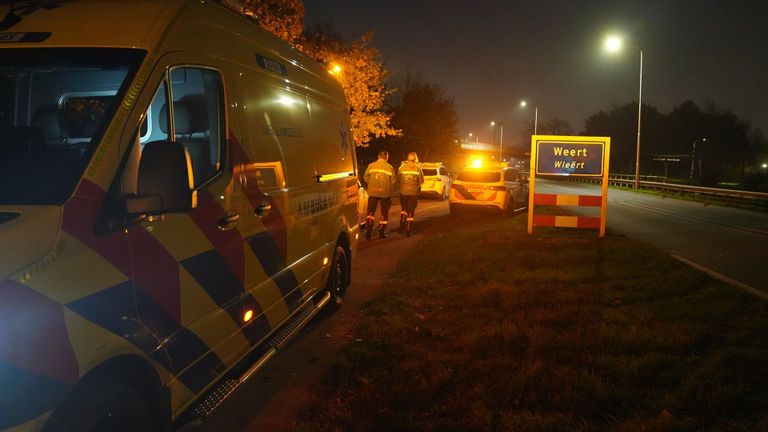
[121,60,254,397]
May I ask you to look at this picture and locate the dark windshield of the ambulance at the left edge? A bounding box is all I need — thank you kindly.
[0,48,145,205]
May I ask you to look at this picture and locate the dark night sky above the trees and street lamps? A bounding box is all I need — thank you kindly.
[304,0,768,150]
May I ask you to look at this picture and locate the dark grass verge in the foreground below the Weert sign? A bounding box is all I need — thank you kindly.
[294,215,768,432]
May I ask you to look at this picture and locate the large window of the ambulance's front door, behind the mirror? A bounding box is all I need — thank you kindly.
[168,67,225,187]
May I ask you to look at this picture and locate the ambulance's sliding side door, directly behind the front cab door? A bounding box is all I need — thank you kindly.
[230,64,308,333]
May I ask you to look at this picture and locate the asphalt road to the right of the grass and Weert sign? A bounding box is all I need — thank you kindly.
[536,178,768,293]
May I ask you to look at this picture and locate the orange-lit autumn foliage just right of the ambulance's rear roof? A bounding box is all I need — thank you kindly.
[302,28,400,147]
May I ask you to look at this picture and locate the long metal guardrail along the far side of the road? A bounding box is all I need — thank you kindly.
[557,174,768,211]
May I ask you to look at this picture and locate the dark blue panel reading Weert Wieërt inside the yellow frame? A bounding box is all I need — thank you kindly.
[536,141,605,176]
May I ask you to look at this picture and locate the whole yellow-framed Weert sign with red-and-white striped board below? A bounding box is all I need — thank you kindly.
[528,135,611,237]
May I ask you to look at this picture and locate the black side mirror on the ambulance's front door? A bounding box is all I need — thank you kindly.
[124,141,196,217]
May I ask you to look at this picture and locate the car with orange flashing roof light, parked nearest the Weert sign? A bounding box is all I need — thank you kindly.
[448,164,528,215]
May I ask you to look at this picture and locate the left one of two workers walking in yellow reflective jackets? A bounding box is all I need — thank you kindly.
[363,151,397,240]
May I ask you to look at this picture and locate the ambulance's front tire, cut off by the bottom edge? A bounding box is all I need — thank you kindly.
[44,384,158,432]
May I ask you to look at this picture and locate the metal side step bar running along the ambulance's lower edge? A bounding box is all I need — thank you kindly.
[186,292,331,424]
